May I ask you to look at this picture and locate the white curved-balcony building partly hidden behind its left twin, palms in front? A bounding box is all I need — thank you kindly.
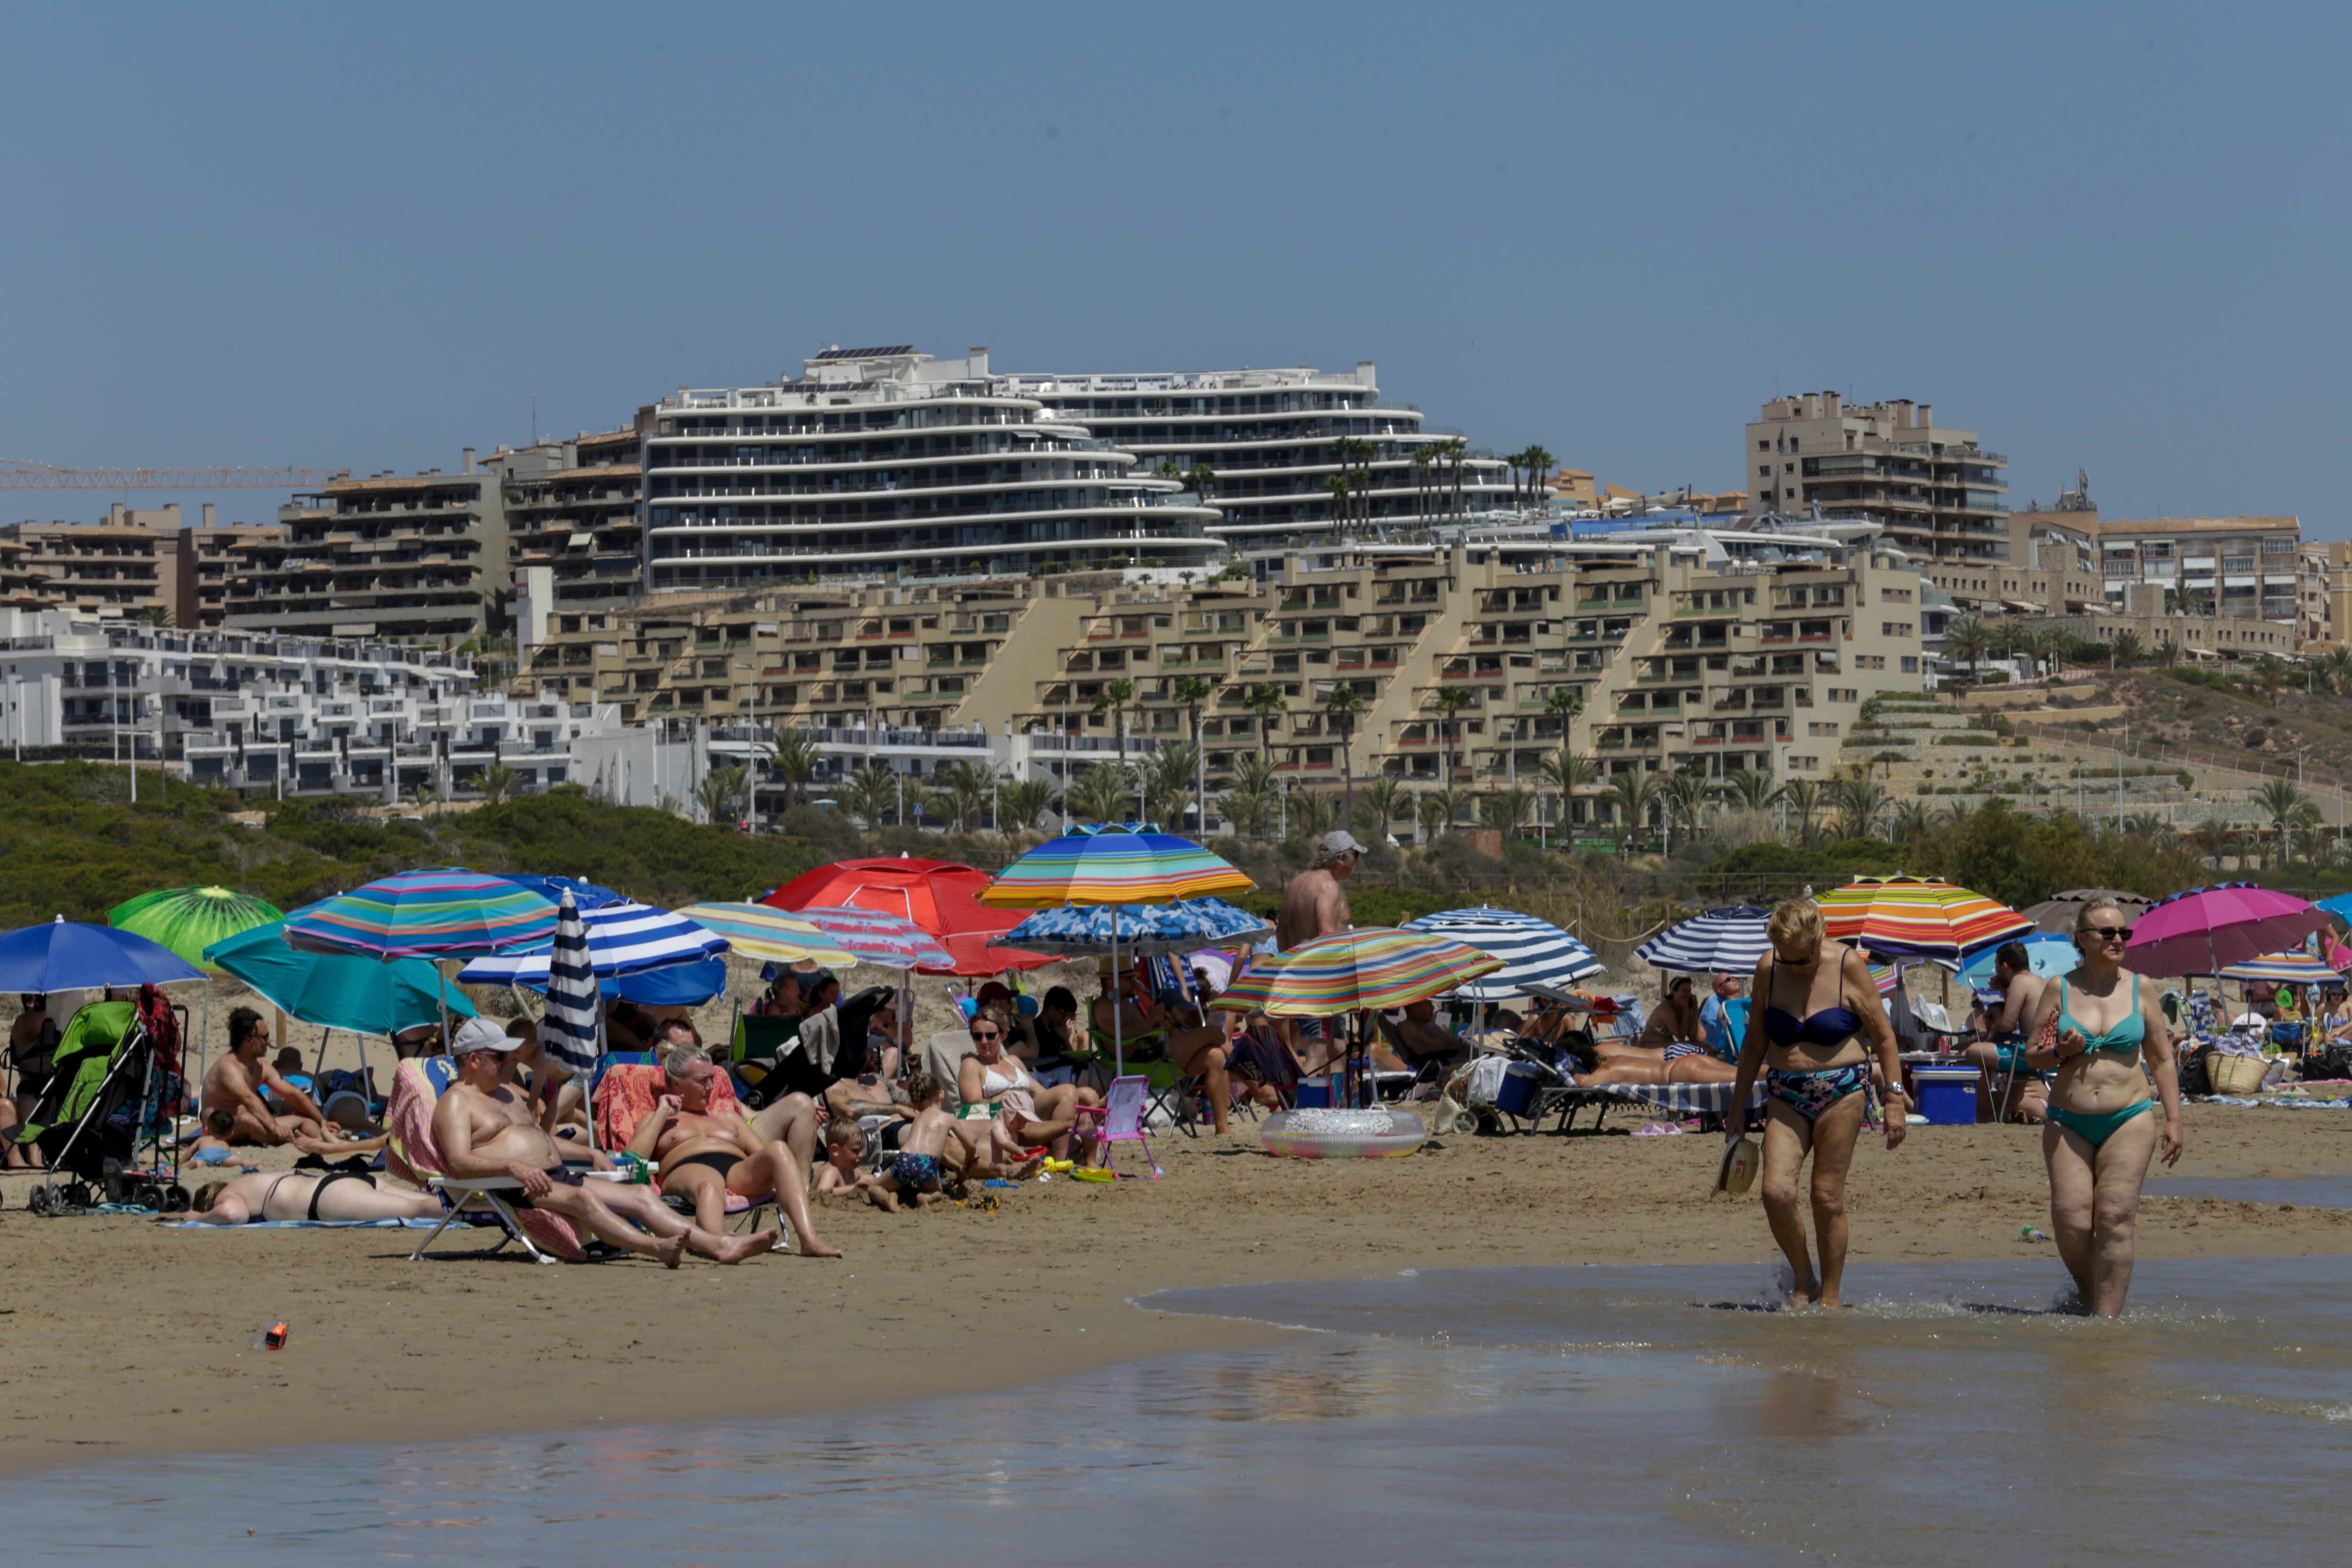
[1000,360,1510,550]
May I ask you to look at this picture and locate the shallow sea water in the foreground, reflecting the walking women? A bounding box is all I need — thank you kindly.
[0,1258,2352,1568]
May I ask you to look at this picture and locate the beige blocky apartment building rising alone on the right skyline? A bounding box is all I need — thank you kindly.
[1743,393,2009,562]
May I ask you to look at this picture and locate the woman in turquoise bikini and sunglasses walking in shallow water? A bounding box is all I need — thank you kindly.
[2025,898,2180,1316]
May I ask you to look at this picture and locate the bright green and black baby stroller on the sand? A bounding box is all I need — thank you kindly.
[16,1001,188,1215]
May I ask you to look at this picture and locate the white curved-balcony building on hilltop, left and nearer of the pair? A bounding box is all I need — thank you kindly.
[637,346,1223,593]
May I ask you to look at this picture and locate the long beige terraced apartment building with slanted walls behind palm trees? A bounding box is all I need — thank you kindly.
[517,529,1924,818]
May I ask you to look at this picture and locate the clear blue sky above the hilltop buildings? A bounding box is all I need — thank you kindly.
[0,2,2352,539]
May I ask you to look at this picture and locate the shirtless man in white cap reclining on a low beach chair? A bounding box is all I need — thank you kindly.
[433,1018,781,1269]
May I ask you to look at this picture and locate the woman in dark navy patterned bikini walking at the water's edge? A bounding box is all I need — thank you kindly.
[1726,898,1903,1307]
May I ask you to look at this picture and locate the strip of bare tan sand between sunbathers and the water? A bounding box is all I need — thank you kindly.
[0,1105,2352,1476]
